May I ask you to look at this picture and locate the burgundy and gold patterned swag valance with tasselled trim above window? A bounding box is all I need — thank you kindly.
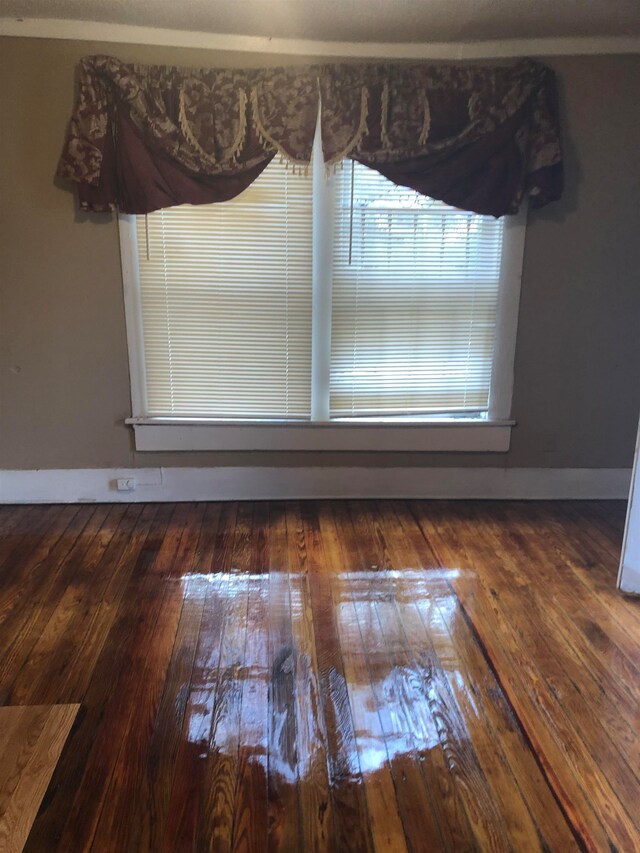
[57,56,562,216]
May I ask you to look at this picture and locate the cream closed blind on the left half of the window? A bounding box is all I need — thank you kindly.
[136,160,312,419]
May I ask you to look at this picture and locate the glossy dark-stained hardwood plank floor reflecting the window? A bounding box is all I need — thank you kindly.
[0,501,640,853]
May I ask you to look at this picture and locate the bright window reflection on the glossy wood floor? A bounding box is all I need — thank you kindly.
[175,567,472,784]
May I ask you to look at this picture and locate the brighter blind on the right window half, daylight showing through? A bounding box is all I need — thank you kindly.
[330,163,503,417]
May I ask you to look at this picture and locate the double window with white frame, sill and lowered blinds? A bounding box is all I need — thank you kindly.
[121,139,524,450]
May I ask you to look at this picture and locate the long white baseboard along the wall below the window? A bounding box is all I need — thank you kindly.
[0,467,631,504]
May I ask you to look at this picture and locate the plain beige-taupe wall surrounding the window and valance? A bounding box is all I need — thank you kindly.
[0,38,640,469]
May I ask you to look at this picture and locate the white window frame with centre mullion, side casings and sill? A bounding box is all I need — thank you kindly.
[118,132,527,452]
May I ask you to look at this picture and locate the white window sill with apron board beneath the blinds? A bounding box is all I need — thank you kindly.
[126,418,514,453]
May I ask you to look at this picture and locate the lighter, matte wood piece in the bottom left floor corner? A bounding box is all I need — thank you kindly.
[0,705,79,853]
